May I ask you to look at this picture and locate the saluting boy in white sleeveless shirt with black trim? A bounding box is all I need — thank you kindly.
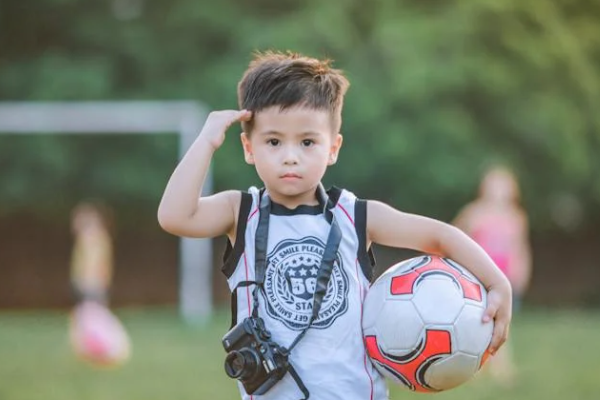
[158,52,511,400]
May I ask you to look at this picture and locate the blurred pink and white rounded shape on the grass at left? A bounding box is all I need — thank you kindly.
[70,301,131,367]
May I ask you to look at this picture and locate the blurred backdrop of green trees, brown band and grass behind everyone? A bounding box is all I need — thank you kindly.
[0,0,600,400]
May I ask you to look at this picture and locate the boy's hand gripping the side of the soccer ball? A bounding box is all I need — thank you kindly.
[483,286,512,355]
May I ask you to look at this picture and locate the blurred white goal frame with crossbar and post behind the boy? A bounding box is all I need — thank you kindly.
[0,101,213,323]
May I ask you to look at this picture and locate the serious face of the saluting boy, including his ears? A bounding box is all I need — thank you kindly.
[242,107,342,207]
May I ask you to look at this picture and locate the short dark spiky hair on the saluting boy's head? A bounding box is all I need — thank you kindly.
[238,51,350,134]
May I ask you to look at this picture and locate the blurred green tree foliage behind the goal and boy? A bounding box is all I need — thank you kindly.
[0,0,600,231]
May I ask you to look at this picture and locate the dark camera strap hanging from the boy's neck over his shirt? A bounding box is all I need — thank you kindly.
[252,184,342,399]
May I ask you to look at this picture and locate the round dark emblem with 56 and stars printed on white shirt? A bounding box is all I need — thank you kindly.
[264,236,348,330]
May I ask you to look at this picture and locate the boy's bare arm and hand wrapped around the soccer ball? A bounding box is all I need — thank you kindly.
[367,201,512,353]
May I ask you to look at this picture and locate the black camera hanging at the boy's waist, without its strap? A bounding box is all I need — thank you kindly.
[222,317,290,395]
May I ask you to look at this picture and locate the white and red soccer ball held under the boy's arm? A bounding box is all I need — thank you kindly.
[362,255,493,392]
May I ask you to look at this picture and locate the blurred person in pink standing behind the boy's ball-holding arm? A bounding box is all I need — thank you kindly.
[453,165,531,386]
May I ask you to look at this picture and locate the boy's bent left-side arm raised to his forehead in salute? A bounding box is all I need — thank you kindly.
[158,110,252,237]
